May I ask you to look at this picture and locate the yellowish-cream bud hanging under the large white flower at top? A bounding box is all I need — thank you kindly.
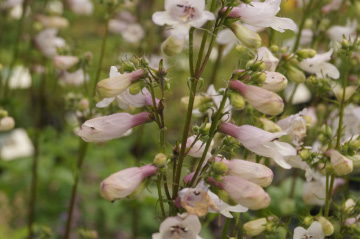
[225,21,261,48]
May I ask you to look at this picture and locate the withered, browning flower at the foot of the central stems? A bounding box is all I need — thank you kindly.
[179,181,219,217]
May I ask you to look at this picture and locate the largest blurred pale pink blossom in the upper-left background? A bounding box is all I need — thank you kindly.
[34,28,66,58]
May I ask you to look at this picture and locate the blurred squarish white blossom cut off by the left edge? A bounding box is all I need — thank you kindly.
[0,129,34,160]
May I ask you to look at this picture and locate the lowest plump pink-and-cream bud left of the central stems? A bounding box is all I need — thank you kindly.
[100,165,158,202]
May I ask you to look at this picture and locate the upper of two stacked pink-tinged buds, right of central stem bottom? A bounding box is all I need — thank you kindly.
[223,159,274,187]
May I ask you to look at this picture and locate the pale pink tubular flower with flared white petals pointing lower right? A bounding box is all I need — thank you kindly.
[220,123,296,169]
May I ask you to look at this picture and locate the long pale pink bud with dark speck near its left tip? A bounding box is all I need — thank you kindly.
[77,112,152,143]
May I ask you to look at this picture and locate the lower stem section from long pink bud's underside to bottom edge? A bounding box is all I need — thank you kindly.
[64,139,88,239]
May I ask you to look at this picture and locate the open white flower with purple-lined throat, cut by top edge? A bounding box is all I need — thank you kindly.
[152,0,215,38]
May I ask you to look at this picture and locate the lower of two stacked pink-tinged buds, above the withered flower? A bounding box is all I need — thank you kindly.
[208,176,270,210]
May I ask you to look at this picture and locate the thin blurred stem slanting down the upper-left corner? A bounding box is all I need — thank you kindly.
[0,0,30,98]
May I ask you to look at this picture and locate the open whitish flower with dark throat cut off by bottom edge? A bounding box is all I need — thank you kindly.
[152,213,202,239]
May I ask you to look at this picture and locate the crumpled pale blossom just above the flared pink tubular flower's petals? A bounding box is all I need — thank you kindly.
[276,109,307,146]
